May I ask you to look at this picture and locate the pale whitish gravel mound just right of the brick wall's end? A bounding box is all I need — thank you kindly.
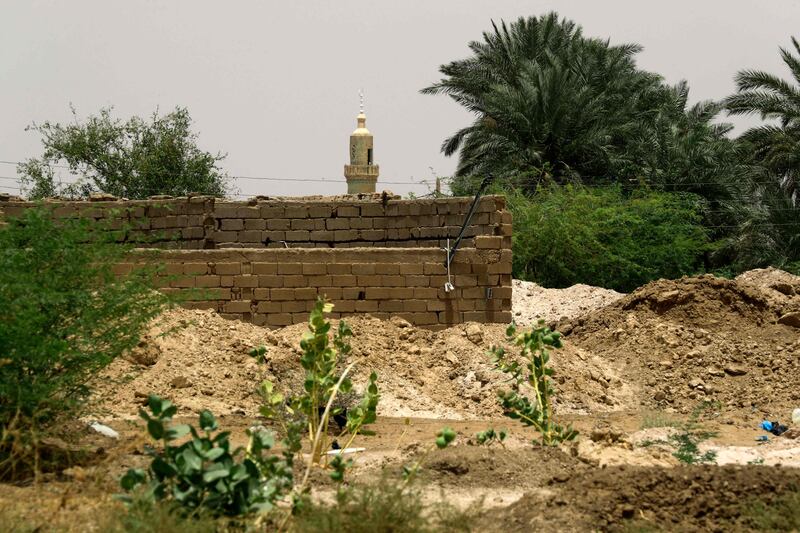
[511,279,624,326]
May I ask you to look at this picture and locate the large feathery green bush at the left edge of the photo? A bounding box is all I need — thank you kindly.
[0,208,169,478]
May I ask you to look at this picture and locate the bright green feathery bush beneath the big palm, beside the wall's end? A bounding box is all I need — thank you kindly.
[508,186,710,292]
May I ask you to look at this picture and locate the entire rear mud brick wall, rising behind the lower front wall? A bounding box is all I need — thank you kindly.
[0,196,511,249]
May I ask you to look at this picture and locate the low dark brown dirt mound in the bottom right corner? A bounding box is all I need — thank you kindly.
[487,466,800,531]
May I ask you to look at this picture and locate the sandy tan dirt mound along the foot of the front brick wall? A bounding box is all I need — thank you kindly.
[89,309,632,419]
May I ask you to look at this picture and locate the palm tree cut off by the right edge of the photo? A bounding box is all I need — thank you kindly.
[725,37,800,206]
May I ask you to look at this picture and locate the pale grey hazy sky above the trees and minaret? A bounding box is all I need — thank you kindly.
[0,0,800,195]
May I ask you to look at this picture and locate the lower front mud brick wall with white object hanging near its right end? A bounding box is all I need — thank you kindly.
[125,242,511,329]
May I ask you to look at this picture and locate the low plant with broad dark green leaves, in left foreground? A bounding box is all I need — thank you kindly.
[120,396,299,516]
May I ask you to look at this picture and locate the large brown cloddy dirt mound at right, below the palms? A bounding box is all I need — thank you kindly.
[560,273,800,418]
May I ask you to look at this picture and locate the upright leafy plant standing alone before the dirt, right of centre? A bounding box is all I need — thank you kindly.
[490,320,578,446]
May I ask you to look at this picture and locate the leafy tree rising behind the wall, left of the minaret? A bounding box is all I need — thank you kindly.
[18,107,228,199]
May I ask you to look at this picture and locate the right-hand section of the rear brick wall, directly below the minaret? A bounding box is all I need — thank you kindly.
[210,196,511,248]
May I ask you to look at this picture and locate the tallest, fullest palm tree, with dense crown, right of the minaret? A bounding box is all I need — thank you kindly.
[422,13,664,191]
